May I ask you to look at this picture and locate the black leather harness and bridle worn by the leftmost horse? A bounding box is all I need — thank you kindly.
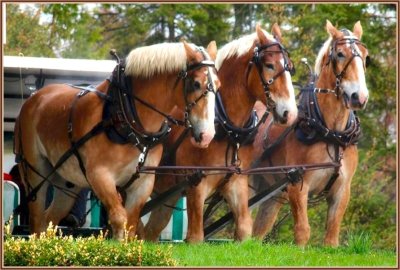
[14,47,216,215]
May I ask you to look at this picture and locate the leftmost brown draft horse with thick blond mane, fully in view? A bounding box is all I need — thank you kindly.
[15,42,220,239]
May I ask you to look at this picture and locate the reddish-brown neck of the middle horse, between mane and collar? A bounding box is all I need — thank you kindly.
[218,58,256,127]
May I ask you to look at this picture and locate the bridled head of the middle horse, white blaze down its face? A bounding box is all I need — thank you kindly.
[247,23,297,125]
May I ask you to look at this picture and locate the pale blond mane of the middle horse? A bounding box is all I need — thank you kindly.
[215,30,275,70]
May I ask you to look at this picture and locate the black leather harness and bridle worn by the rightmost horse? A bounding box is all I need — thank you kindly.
[256,29,369,193]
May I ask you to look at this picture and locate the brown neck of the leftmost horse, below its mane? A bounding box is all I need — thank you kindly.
[132,75,179,132]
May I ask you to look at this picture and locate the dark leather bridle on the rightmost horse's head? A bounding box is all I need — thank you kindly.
[326,29,370,98]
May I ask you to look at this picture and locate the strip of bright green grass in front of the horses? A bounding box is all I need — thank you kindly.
[167,240,397,267]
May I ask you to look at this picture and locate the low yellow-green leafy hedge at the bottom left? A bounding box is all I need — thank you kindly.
[4,225,176,266]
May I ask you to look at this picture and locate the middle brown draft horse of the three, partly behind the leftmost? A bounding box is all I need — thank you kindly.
[145,24,297,242]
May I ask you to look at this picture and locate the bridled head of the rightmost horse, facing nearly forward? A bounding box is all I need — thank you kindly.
[315,20,369,110]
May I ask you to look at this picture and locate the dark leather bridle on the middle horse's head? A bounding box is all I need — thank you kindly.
[252,42,295,111]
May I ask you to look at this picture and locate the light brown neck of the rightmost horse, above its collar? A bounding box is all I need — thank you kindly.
[315,68,350,131]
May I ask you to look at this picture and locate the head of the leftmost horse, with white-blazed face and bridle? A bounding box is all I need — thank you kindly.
[183,41,221,148]
